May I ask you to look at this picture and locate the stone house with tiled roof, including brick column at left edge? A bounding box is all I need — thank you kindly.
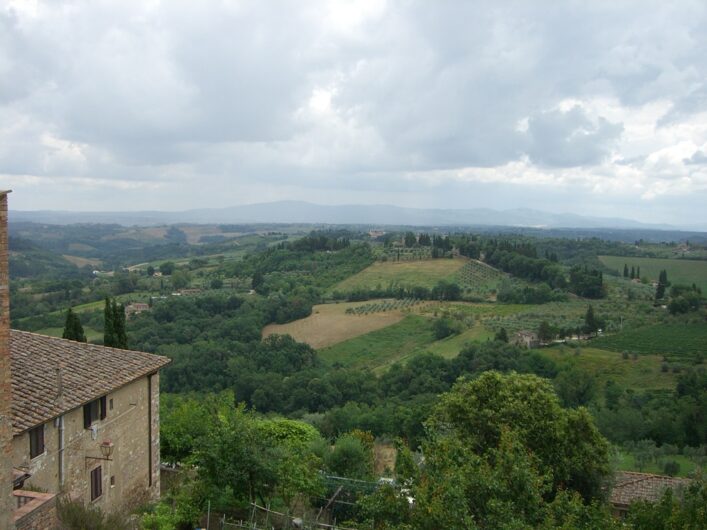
[0,192,169,530]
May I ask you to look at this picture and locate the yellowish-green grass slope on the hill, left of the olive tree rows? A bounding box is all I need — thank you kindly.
[332,258,467,292]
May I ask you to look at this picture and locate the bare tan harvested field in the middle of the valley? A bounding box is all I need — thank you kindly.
[263,302,404,349]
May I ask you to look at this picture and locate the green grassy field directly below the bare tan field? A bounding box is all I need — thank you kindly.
[319,315,435,372]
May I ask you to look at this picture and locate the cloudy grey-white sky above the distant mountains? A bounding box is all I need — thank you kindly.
[0,0,707,226]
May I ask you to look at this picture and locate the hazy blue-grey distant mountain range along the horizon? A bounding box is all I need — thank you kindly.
[10,201,695,230]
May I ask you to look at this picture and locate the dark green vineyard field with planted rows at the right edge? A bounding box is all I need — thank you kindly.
[592,323,707,361]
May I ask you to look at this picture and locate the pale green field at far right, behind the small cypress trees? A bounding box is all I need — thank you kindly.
[599,256,707,294]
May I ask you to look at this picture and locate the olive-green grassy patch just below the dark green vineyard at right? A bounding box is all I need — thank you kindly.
[539,344,677,391]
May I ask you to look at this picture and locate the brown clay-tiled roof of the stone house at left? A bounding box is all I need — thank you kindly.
[10,329,171,435]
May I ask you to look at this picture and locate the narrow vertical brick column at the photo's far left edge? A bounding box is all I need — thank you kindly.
[0,191,15,530]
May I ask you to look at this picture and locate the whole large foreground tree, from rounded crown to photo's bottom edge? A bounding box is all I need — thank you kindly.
[404,371,614,530]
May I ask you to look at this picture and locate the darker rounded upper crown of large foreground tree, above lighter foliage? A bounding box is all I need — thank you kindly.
[425,371,610,500]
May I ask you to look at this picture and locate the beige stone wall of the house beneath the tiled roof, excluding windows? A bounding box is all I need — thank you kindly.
[13,374,160,512]
